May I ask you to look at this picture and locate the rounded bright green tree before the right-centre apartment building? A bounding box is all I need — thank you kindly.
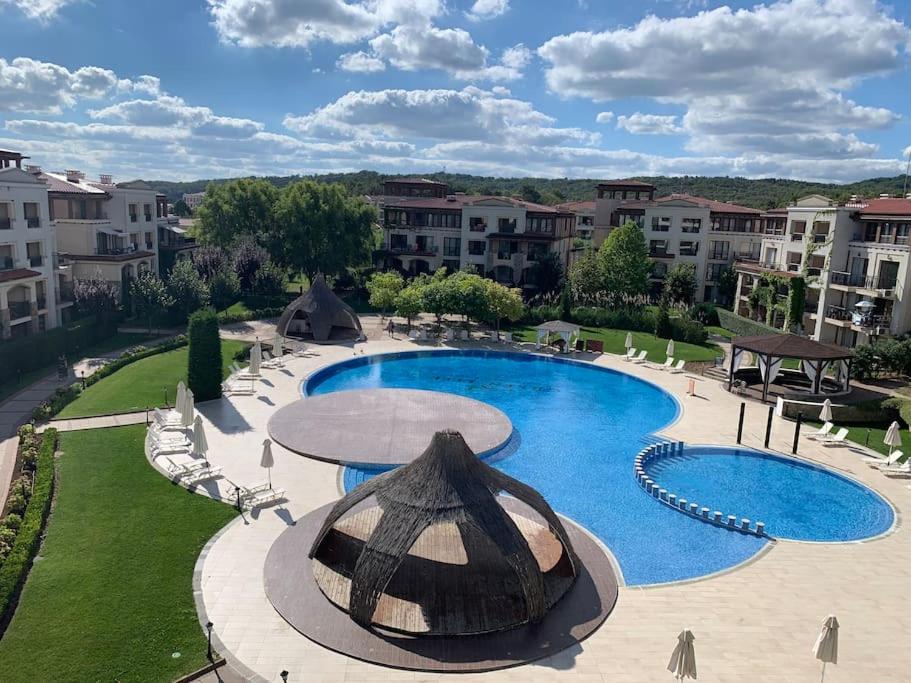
[598,222,652,304]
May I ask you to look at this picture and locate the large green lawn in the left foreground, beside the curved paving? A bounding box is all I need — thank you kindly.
[0,425,236,683]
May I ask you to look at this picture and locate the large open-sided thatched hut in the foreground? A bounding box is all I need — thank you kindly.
[310,431,580,635]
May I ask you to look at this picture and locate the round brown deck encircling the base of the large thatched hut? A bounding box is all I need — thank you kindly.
[264,498,618,673]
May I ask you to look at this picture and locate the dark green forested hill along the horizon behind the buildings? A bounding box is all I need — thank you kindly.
[149,171,905,209]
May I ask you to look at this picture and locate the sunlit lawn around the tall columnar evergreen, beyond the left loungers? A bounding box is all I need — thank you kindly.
[58,340,248,418]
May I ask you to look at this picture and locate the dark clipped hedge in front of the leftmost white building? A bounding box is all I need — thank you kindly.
[0,318,117,383]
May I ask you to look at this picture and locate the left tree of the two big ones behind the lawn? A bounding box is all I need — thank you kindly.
[195,178,278,247]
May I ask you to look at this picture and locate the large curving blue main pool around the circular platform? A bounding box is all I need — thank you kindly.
[305,351,767,585]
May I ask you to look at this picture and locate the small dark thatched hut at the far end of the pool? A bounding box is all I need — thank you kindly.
[277,275,363,344]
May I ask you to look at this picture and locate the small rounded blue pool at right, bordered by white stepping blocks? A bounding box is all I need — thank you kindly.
[645,446,894,542]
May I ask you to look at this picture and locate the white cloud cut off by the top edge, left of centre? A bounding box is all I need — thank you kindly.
[208,0,443,48]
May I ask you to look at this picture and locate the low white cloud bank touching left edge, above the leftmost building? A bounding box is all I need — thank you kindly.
[0,57,118,114]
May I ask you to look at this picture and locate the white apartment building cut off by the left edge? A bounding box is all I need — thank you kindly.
[0,150,62,339]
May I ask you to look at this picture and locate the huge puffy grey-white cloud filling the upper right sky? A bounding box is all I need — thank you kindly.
[538,0,911,157]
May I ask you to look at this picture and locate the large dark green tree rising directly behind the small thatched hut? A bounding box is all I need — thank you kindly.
[269,180,376,281]
